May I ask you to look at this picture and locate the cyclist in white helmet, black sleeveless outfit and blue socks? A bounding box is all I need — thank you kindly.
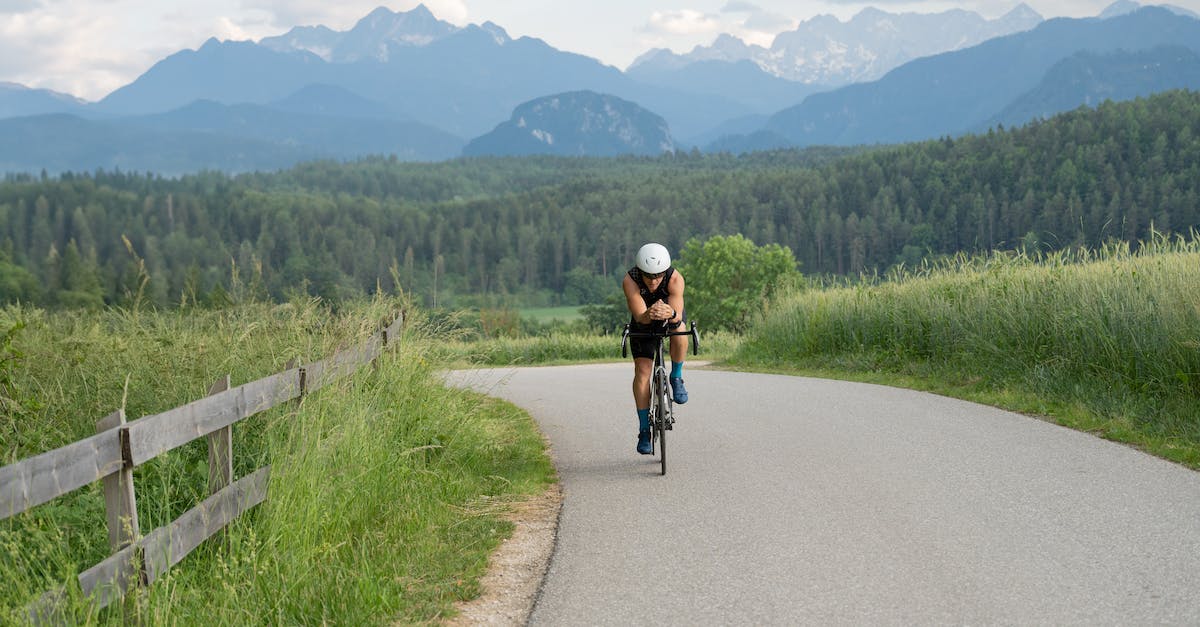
[622,243,688,455]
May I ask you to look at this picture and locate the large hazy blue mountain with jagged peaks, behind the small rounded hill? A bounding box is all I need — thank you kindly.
[84,7,739,137]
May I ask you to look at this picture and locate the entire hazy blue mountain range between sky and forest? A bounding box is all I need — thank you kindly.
[0,0,1200,174]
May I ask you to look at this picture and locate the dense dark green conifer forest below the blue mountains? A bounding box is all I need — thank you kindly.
[0,91,1200,306]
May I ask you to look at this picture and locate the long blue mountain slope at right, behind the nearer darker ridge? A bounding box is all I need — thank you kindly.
[766,7,1200,145]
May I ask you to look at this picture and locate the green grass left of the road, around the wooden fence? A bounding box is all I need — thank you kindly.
[0,301,554,625]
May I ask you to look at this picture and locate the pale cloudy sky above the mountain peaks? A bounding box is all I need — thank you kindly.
[0,0,1200,100]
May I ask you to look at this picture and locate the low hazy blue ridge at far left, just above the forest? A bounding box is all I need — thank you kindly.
[0,101,463,174]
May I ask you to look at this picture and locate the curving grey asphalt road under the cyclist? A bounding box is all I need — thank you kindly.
[451,363,1200,626]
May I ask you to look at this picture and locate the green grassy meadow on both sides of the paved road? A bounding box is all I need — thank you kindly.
[0,231,1200,625]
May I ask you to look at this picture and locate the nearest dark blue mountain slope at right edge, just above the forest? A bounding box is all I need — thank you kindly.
[980,46,1200,130]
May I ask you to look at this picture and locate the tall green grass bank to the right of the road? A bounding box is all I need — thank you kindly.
[734,238,1200,465]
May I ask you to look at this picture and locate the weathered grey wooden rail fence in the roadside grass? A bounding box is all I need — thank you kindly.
[0,314,404,622]
